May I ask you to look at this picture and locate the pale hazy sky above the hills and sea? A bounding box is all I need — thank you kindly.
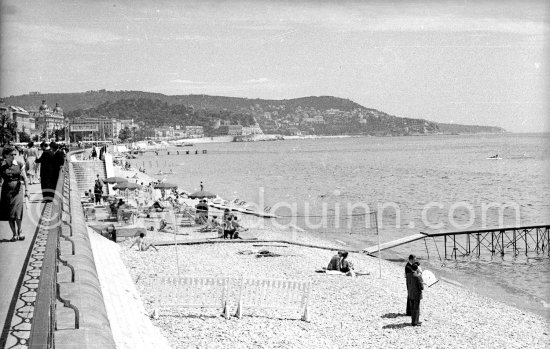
[0,0,550,132]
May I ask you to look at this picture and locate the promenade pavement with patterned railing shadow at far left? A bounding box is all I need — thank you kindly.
[0,184,44,348]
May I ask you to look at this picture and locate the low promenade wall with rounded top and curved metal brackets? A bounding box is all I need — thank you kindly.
[29,154,115,348]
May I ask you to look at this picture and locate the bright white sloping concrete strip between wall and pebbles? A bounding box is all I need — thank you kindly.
[88,228,170,349]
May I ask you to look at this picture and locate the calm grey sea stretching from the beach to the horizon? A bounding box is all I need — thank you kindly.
[131,133,550,319]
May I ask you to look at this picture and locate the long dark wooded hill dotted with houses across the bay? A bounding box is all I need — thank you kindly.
[3,90,504,136]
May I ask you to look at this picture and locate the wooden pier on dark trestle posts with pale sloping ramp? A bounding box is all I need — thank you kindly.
[363,225,550,259]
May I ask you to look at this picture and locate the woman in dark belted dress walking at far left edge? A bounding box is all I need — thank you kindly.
[0,147,28,241]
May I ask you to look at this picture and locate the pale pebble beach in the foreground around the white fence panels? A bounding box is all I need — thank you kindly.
[115,167,550,348]
